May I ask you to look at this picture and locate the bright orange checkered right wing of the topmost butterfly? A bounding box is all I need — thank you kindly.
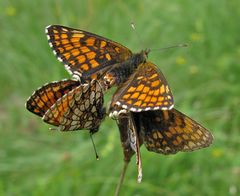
[111,62,173,112]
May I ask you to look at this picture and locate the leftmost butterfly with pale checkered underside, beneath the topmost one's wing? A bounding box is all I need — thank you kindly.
[26,80,105,132]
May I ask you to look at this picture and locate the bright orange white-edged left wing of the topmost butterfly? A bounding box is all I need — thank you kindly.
[46,25,132,79]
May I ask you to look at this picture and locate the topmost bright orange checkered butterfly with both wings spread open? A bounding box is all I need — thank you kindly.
[46,25,174,112]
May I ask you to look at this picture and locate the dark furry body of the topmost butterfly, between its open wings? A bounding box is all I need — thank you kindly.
[104,50,149,88]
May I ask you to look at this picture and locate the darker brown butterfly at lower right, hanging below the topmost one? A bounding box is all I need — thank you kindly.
[110,107,213,186]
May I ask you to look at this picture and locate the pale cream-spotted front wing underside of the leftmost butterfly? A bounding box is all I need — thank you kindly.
[43,80,105,131]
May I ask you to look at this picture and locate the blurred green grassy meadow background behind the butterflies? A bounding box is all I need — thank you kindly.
[0,0,240,195]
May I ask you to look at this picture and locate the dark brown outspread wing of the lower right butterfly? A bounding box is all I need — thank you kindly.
[134,109,213,154]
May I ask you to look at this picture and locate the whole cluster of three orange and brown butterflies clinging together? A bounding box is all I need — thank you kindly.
[26,25,212,190]
